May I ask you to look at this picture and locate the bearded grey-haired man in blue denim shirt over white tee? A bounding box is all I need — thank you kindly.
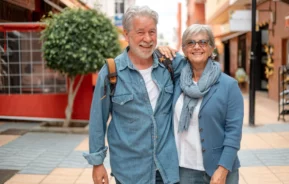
[84,6,182,184]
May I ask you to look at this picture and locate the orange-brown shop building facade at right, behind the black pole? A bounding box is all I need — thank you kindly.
[205,0,289,100]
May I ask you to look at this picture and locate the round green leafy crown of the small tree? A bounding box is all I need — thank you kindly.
[41,9,120,77]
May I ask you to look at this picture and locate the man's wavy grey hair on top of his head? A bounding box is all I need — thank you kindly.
[122,6,159,31]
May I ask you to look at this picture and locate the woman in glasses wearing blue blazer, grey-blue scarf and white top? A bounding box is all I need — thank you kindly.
[173,24,244,184]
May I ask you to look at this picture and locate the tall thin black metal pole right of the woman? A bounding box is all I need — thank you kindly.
[249,0,257,126]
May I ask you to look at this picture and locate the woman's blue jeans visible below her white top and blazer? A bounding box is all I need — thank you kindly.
[180,167,239,184]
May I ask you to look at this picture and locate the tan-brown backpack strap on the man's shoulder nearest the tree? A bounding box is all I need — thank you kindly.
[106,58,117,96]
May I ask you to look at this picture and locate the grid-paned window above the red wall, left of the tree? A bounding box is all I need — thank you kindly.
[0,31,66,94]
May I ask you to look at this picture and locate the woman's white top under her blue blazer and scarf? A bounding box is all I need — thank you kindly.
[174,93,205,171]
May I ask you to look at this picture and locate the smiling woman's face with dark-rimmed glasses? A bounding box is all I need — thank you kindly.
[183,33,214,65]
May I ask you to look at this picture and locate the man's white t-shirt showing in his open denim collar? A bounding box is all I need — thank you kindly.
[139,66,160,111]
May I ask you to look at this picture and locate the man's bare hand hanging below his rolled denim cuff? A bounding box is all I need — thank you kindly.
[92,164,109,184]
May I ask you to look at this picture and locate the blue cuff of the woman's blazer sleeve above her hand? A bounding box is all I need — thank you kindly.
[219,146,238,172]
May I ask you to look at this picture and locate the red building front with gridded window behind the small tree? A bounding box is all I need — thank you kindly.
[0,0,133,121]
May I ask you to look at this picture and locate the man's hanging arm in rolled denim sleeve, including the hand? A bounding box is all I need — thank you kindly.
[83,66,110,184]
